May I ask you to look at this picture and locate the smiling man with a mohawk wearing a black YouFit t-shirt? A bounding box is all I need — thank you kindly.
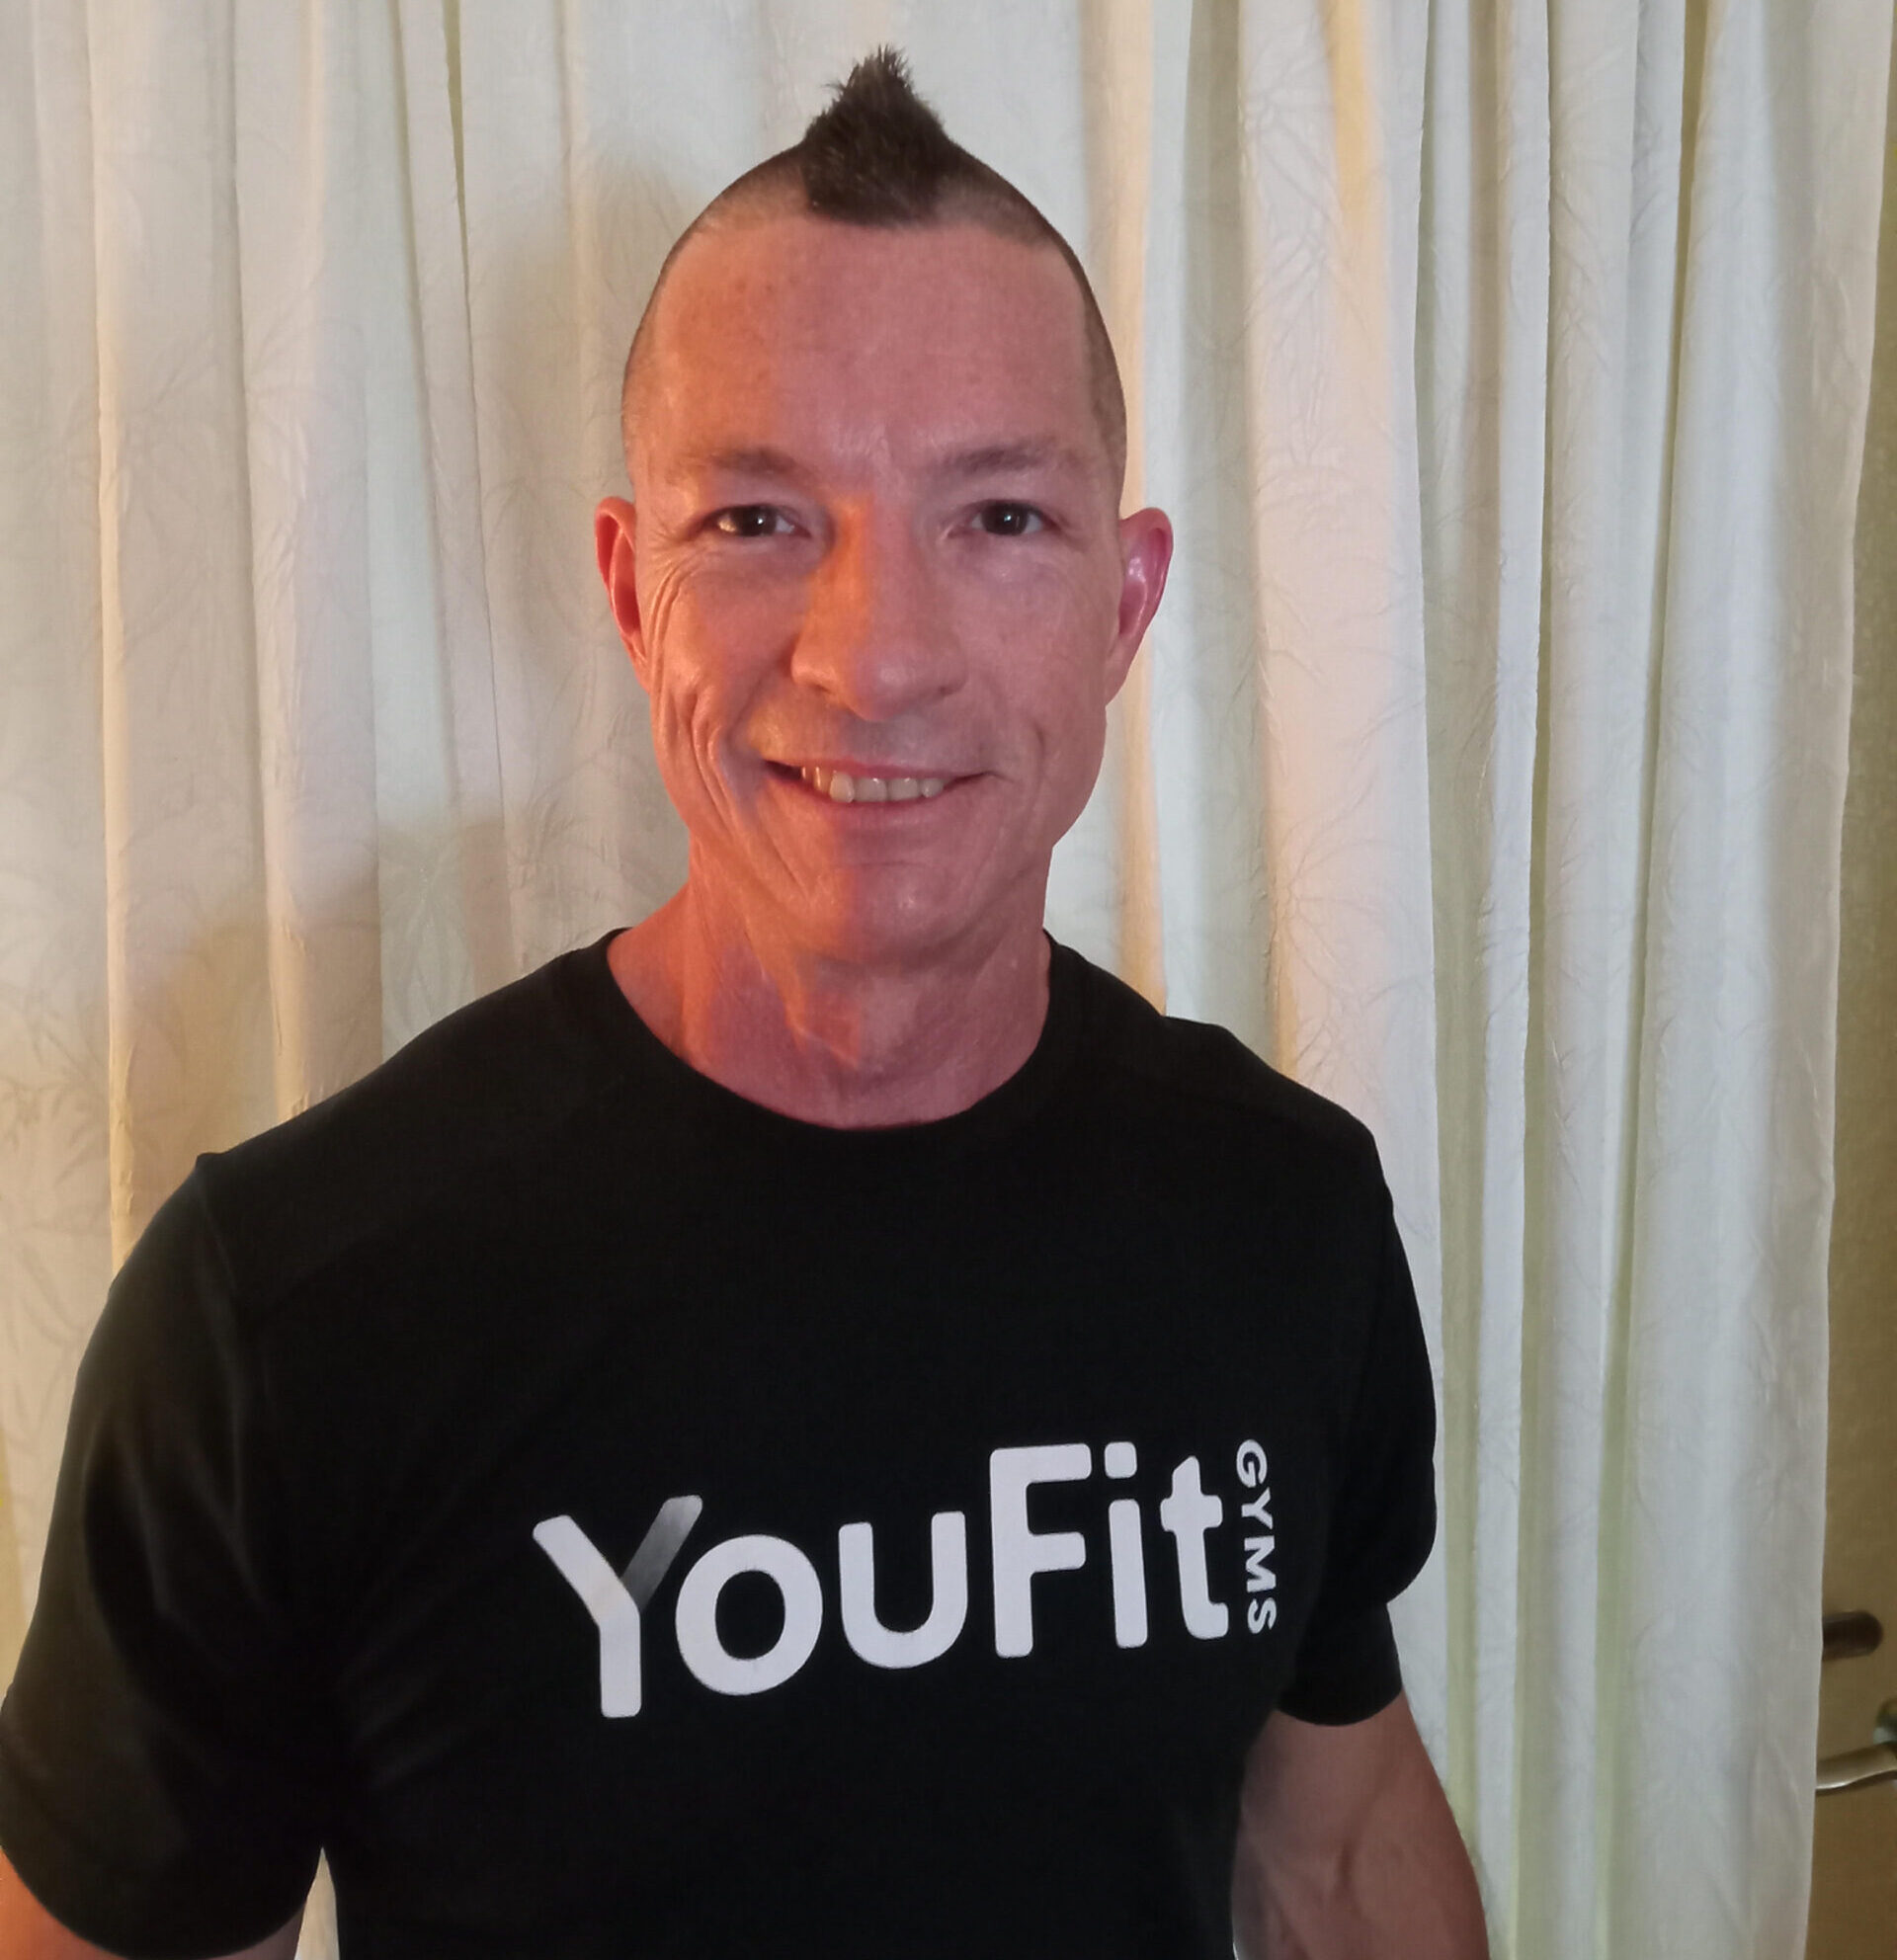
[0,55,1483,1960]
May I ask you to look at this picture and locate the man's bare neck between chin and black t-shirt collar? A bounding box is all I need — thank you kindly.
[610,884,1048,1129]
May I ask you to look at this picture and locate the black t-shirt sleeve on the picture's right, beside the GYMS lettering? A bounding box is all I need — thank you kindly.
[1278,1168,1437,1723]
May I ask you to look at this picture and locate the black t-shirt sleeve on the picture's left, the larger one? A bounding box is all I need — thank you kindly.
[0,1178,327,1960]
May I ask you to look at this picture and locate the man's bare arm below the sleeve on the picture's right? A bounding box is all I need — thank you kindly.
[1233,1695,1489,1960]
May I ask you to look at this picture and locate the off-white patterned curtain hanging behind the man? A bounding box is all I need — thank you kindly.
[0,0,1891,1960]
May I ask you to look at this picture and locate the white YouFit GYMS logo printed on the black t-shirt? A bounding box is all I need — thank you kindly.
[534,1440,1278,1717]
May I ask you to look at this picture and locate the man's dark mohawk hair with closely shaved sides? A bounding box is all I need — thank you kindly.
[619,47,1126,482]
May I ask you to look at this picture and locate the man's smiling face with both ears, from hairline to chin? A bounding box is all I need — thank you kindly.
[600,213,1170,968]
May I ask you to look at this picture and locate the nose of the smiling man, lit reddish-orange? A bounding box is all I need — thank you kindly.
[789,512,966,721]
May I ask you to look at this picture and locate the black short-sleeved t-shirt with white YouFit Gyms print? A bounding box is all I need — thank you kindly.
[0,940,1435,1960]
